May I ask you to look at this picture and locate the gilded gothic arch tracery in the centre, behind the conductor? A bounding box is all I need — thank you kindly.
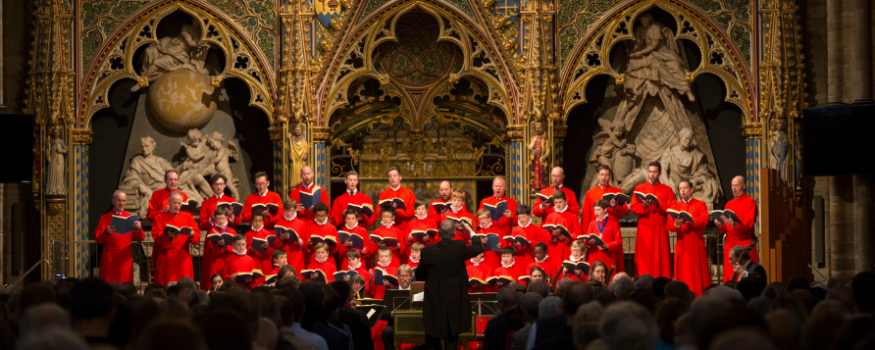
[311,0,518,125]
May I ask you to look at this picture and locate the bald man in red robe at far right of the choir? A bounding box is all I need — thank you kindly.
[714,176,760,281]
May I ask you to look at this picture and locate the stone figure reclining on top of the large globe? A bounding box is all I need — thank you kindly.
[131,18,210,91]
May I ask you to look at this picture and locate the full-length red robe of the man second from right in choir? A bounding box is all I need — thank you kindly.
[666,199,712,298]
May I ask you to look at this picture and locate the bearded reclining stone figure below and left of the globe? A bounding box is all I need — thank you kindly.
[119,136,184,217]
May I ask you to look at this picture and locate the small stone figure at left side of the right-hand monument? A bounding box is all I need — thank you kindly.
[589,118,636,187]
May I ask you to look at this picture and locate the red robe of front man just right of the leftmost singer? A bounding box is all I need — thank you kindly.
[152,211,201,287]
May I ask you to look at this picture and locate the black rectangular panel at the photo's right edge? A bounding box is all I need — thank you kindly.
[802,103,875,176]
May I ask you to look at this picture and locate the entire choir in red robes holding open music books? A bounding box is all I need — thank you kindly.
[95,162,756,299]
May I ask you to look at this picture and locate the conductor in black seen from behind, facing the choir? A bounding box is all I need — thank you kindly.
[416,220,483,350]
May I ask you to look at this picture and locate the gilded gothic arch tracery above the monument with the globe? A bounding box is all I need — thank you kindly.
[79,0,276,129]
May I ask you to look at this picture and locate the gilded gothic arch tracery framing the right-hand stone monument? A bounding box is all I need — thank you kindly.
[559,0,755,123]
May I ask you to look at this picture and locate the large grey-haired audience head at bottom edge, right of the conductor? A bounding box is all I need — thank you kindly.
[599,301,659,350]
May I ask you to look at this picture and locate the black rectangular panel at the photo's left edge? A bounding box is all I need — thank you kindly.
[0,114,37,183]
